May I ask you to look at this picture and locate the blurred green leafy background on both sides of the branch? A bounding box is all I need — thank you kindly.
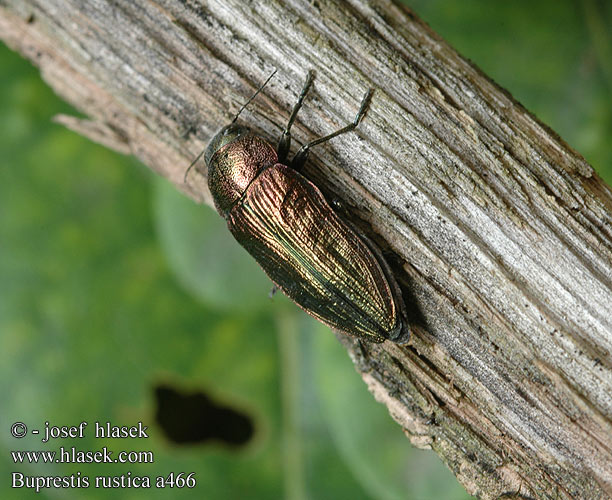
[0,0,612,499]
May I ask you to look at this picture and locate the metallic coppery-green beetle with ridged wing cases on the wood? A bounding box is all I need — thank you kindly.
[185,71,410,344]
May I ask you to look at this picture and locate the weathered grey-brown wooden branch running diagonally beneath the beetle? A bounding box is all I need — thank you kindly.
[0,0,612,499]
